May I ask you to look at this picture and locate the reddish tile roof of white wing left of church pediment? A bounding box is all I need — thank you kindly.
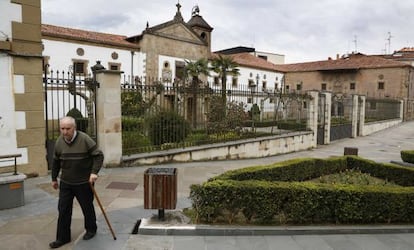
[42,24,139,49]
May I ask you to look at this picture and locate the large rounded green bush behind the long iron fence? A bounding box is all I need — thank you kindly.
[148,111,190,145]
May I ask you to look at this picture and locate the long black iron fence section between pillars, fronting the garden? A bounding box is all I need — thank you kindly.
[121,78,310,155]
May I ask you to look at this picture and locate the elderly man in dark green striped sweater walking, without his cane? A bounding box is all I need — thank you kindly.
[49,116,104,248]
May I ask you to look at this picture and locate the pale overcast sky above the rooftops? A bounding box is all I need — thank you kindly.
[42,0,414,63]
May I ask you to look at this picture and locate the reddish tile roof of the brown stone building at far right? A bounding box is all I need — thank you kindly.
[276,54,410,72]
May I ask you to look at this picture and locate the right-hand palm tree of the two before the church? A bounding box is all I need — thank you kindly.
[211,55,240,107]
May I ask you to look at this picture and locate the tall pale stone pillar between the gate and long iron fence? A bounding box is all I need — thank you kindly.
[96,70,122,167]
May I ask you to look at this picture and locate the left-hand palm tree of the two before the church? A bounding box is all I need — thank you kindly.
[184,58,210,128]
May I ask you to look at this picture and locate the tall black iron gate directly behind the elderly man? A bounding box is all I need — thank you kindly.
[43,67,98,169]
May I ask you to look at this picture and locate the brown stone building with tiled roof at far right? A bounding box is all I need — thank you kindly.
[277,53,414,120]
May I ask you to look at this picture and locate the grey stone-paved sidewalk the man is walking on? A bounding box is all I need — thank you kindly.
[0,122,414,250]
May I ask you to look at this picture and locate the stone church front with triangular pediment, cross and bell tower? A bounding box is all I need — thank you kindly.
[126,3,213,83]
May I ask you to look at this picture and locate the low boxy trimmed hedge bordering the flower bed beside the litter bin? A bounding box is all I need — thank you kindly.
[190,156,414,224]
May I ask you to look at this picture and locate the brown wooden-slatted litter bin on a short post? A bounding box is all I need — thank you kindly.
[144,168,177,220]
